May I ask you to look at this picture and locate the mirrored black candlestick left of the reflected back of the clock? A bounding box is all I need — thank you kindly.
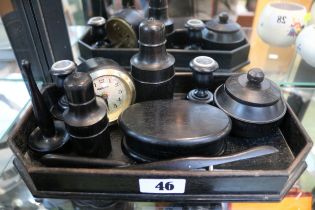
[87,16,108,48]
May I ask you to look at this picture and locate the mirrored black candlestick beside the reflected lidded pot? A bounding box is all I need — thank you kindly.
[185,19,205,50]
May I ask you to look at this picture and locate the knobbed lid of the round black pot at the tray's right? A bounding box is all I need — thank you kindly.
[225,68,281,106]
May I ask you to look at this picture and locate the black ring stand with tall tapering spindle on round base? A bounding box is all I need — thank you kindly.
[21,60,69,153]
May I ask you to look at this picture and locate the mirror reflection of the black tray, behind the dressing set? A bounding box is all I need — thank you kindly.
[78,29,250,72]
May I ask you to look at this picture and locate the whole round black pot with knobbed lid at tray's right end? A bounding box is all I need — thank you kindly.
[214,69,287,137]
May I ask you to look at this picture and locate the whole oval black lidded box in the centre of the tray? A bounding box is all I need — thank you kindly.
[118,100,231,162]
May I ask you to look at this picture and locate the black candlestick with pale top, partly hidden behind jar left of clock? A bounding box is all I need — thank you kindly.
[50,60,77,120]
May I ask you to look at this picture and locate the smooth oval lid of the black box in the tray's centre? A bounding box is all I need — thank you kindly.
[118,100,231,146]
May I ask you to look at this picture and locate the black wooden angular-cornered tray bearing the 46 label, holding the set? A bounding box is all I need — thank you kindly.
[9,73,312,202]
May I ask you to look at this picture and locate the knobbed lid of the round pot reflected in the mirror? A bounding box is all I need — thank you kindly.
[206,12,241,33]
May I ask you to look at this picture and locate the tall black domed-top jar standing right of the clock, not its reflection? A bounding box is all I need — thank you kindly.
[130,19,175,102]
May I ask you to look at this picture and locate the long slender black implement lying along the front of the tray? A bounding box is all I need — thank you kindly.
[41,146,278,170]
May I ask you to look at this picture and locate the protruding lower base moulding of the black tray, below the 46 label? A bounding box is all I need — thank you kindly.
[14,159,307,202]
